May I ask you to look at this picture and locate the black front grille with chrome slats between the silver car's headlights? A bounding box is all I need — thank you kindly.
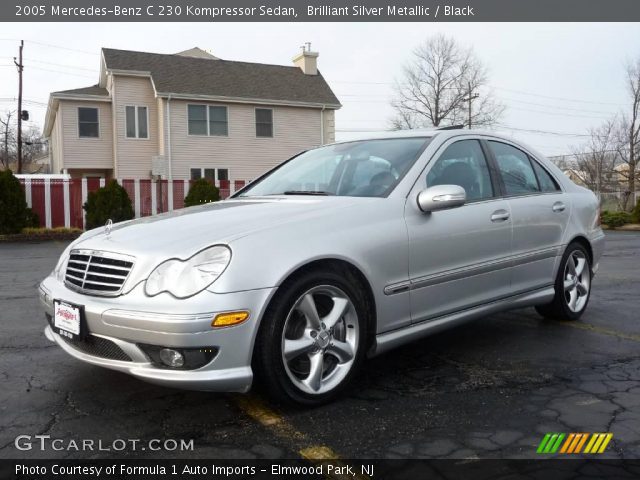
[64,250,133,296]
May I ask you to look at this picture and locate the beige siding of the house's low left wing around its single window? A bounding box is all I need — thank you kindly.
[54,100,113,171]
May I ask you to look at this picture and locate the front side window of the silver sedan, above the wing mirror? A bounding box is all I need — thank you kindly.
[427,140,494,202]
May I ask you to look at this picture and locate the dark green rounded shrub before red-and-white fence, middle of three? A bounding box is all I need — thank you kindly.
[82,180,133,230]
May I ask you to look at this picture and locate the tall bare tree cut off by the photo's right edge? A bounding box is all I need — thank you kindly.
[618,58,640,210]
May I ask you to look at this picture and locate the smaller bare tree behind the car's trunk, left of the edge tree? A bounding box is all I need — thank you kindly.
[573,120,619,194]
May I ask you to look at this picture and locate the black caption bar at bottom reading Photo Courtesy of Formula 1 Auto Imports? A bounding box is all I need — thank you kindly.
[0,458,640,480]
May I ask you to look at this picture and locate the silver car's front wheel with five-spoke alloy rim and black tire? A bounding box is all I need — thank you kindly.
[252,270,371,406]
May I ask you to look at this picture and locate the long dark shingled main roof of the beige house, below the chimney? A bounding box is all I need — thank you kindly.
[102,48,340,107]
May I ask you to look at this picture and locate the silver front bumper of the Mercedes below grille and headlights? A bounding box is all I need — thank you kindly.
[39,276,275,392]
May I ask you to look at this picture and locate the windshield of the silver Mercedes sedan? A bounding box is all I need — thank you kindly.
[238,137,430,197]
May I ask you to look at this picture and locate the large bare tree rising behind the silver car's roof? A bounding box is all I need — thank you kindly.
[390,35,504,130]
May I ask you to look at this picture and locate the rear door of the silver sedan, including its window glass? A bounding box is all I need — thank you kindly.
[487,140,571,293]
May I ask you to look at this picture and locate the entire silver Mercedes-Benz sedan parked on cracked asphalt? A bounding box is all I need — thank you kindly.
[40,130,604,404]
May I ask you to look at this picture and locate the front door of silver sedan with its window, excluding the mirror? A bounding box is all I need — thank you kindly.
[405,140,512,322]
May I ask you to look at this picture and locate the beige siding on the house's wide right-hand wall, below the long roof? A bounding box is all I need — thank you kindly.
[170,100,320,180]
